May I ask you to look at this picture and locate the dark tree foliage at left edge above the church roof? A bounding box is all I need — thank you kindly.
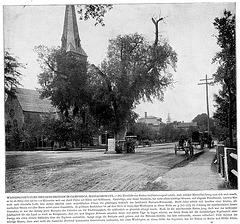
[4,51,24,97]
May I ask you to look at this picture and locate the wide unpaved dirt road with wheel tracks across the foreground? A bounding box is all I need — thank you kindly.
[6,144,190,193]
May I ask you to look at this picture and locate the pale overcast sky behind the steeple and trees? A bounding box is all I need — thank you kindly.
[3,1,236,122]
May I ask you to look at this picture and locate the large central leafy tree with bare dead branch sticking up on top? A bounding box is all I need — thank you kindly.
[90,18,177,139]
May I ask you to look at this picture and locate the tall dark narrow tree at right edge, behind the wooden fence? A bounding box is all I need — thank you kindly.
[213,10,236,146]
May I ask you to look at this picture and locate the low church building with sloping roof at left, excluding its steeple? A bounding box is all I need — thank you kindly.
[5,88,58,148]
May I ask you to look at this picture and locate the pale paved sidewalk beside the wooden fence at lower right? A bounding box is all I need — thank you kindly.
[154,148,224,191]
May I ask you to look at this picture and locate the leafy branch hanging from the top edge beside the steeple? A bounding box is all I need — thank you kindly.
[77,4,112,26]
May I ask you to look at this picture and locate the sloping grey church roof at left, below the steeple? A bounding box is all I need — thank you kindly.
[16,88,56,113]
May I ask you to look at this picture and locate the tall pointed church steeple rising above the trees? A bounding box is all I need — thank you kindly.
[62,5,87,61]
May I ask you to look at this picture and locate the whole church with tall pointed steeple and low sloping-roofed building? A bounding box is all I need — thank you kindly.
[5,5,88,148]
